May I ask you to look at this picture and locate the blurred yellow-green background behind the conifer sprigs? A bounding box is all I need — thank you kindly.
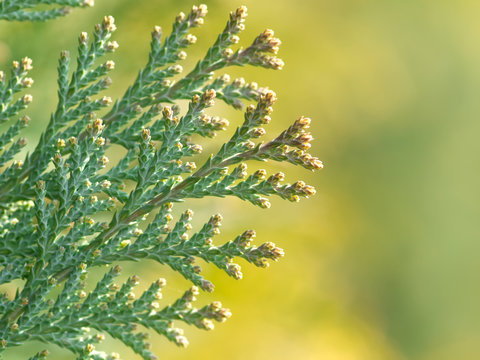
[0,0,480,360]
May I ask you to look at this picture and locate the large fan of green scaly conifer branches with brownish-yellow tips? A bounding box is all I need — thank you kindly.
[0,1,323,359]
